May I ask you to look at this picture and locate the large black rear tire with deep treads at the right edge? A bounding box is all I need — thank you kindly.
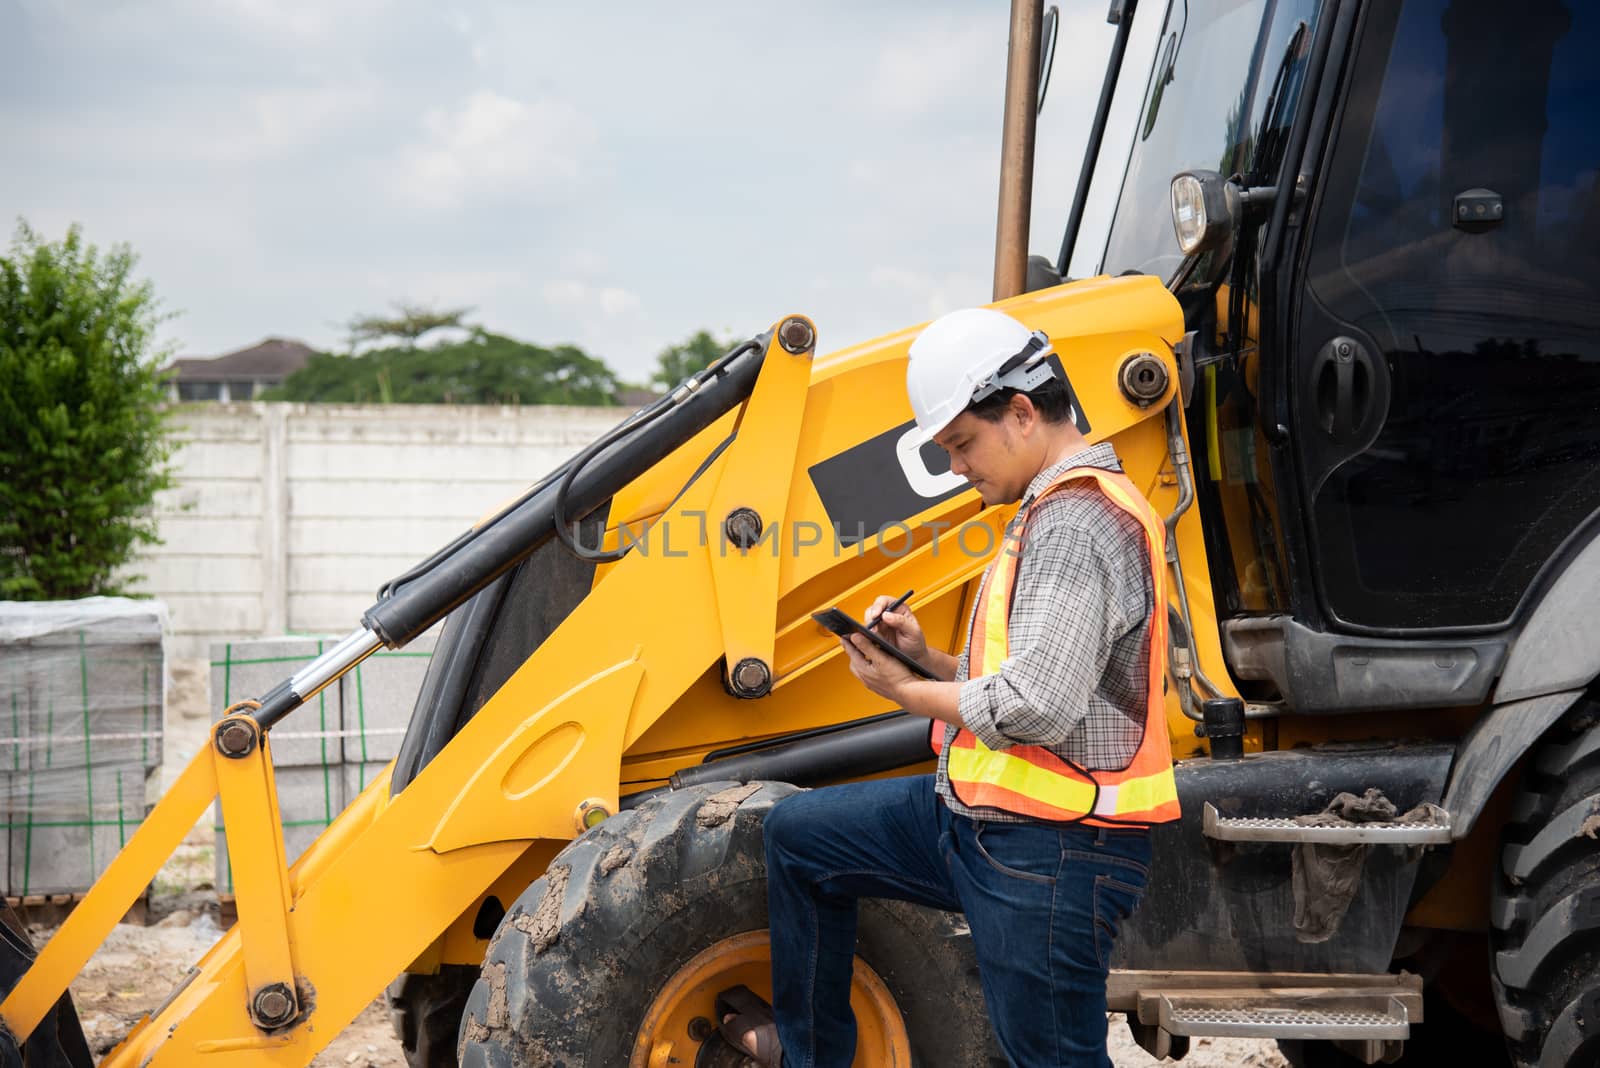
[1490,699,1600,1068]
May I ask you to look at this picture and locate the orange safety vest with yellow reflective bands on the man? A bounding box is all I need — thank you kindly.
[930,467,1178,827]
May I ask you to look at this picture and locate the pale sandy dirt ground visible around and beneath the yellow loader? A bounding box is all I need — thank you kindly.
[40,660,1286,1068]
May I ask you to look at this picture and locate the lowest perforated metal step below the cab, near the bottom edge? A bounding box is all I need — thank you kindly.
[1157,991,1411,1039]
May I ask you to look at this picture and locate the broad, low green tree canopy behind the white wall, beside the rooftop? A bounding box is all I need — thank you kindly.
[266,328,618,404]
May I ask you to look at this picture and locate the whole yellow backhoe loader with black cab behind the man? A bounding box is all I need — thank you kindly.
[0,0,1600,1068]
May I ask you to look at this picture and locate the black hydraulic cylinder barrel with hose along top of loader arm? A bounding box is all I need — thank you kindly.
[362,337,766,649]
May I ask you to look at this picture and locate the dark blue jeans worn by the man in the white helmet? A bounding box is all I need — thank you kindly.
[765,775,1150,1068]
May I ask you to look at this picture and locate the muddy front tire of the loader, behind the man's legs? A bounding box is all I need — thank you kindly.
[461,783,1005,1068]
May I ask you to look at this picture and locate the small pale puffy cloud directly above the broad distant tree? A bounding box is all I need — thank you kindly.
[395,90,595,209]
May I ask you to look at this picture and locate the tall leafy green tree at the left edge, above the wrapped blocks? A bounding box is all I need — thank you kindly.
[0,222,173,601]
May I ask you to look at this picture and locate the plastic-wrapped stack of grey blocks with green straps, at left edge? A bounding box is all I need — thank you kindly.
[0,598,166,897]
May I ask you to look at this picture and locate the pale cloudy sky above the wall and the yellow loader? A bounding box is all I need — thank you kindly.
[0,0,1160,381]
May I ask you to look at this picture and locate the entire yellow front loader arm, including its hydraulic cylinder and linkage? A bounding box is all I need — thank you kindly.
[0,278,1187,1066]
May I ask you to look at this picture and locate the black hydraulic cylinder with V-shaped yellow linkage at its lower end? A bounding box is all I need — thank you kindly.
[0,334,770,1061]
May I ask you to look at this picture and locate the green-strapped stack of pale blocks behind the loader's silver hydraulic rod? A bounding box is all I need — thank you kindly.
[211,635,434,895]
